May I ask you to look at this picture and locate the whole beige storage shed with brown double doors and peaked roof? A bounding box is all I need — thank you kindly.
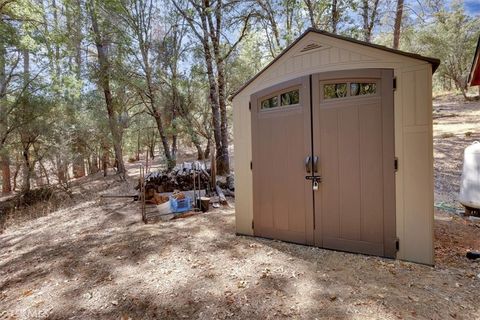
[232,29,440,265]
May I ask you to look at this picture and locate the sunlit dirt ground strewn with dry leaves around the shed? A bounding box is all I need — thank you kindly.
[0,94,480,319]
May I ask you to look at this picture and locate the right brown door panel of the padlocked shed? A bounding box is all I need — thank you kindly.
[313,69,395,257]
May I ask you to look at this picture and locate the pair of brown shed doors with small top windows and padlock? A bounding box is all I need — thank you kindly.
[251,69,396,257]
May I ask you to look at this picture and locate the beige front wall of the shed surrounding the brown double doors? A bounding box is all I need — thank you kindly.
[233,33,434,264]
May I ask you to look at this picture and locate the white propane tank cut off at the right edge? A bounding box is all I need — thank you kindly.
[458,141,480,210]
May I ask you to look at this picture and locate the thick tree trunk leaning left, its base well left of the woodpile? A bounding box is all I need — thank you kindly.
[90,0,126,180]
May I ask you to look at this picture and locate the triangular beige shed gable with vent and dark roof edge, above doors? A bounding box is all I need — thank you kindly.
[230,28,440,99]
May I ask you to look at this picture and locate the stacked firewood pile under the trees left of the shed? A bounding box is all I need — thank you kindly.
[145,162,211,193]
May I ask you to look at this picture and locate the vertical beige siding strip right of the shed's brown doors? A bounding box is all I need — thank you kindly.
[395,64,434,264]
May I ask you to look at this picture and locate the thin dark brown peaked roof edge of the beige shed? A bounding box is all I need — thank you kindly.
[230,28,440,100]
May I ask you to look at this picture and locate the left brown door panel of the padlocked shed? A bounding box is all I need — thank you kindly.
[251,77,313,244]
